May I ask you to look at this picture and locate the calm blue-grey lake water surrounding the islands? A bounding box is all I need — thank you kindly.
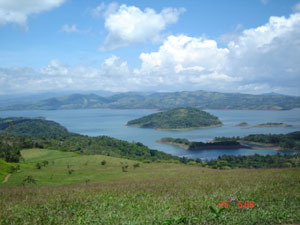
[0,109,300,159]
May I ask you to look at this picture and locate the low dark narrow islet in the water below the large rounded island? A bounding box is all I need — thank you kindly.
[157,137,250,150]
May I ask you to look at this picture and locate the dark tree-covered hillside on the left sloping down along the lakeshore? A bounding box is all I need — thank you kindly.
[0,118,179,162]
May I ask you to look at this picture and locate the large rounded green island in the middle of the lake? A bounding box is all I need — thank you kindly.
[126,107,223,130]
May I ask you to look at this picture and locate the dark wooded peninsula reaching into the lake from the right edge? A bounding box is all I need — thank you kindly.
[215,131,300,151]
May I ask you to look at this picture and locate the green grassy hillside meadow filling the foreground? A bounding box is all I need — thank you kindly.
[0,149,300,224]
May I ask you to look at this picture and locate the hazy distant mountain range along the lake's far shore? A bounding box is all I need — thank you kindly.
[0,91,300,110]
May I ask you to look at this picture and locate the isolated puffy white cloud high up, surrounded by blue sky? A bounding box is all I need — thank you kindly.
[98,5,185,50]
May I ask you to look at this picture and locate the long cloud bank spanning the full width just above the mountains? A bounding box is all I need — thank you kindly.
[0,13,300,95]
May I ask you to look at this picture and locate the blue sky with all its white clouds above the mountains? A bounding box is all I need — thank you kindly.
[0,0,300,96]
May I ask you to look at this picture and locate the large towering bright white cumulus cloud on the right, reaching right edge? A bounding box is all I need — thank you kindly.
[134,13,300,94]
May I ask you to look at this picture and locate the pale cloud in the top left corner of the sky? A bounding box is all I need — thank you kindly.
[0,0,65,29]
